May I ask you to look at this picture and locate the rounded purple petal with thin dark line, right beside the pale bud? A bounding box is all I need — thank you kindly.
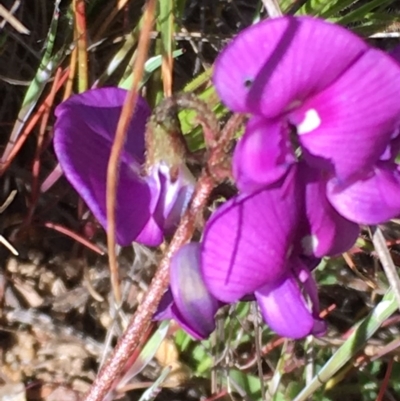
[202,170,302,302]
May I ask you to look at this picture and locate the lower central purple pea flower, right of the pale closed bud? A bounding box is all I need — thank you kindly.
[201,168,332,338]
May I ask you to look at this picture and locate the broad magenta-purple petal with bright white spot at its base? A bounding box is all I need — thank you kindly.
[289,46,400,181]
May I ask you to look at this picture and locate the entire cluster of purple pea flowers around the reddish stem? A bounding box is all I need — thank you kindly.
[55,17,400,338]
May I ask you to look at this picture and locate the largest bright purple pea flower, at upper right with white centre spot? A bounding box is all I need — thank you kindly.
[214,17,400,224]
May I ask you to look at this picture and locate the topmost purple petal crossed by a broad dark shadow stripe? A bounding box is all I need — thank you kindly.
[214,16,369,118]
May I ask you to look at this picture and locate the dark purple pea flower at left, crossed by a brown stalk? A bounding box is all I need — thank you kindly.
[54,88,193,246]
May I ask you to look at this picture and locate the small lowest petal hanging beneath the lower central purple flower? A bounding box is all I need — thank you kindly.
[255,260,325,339]
